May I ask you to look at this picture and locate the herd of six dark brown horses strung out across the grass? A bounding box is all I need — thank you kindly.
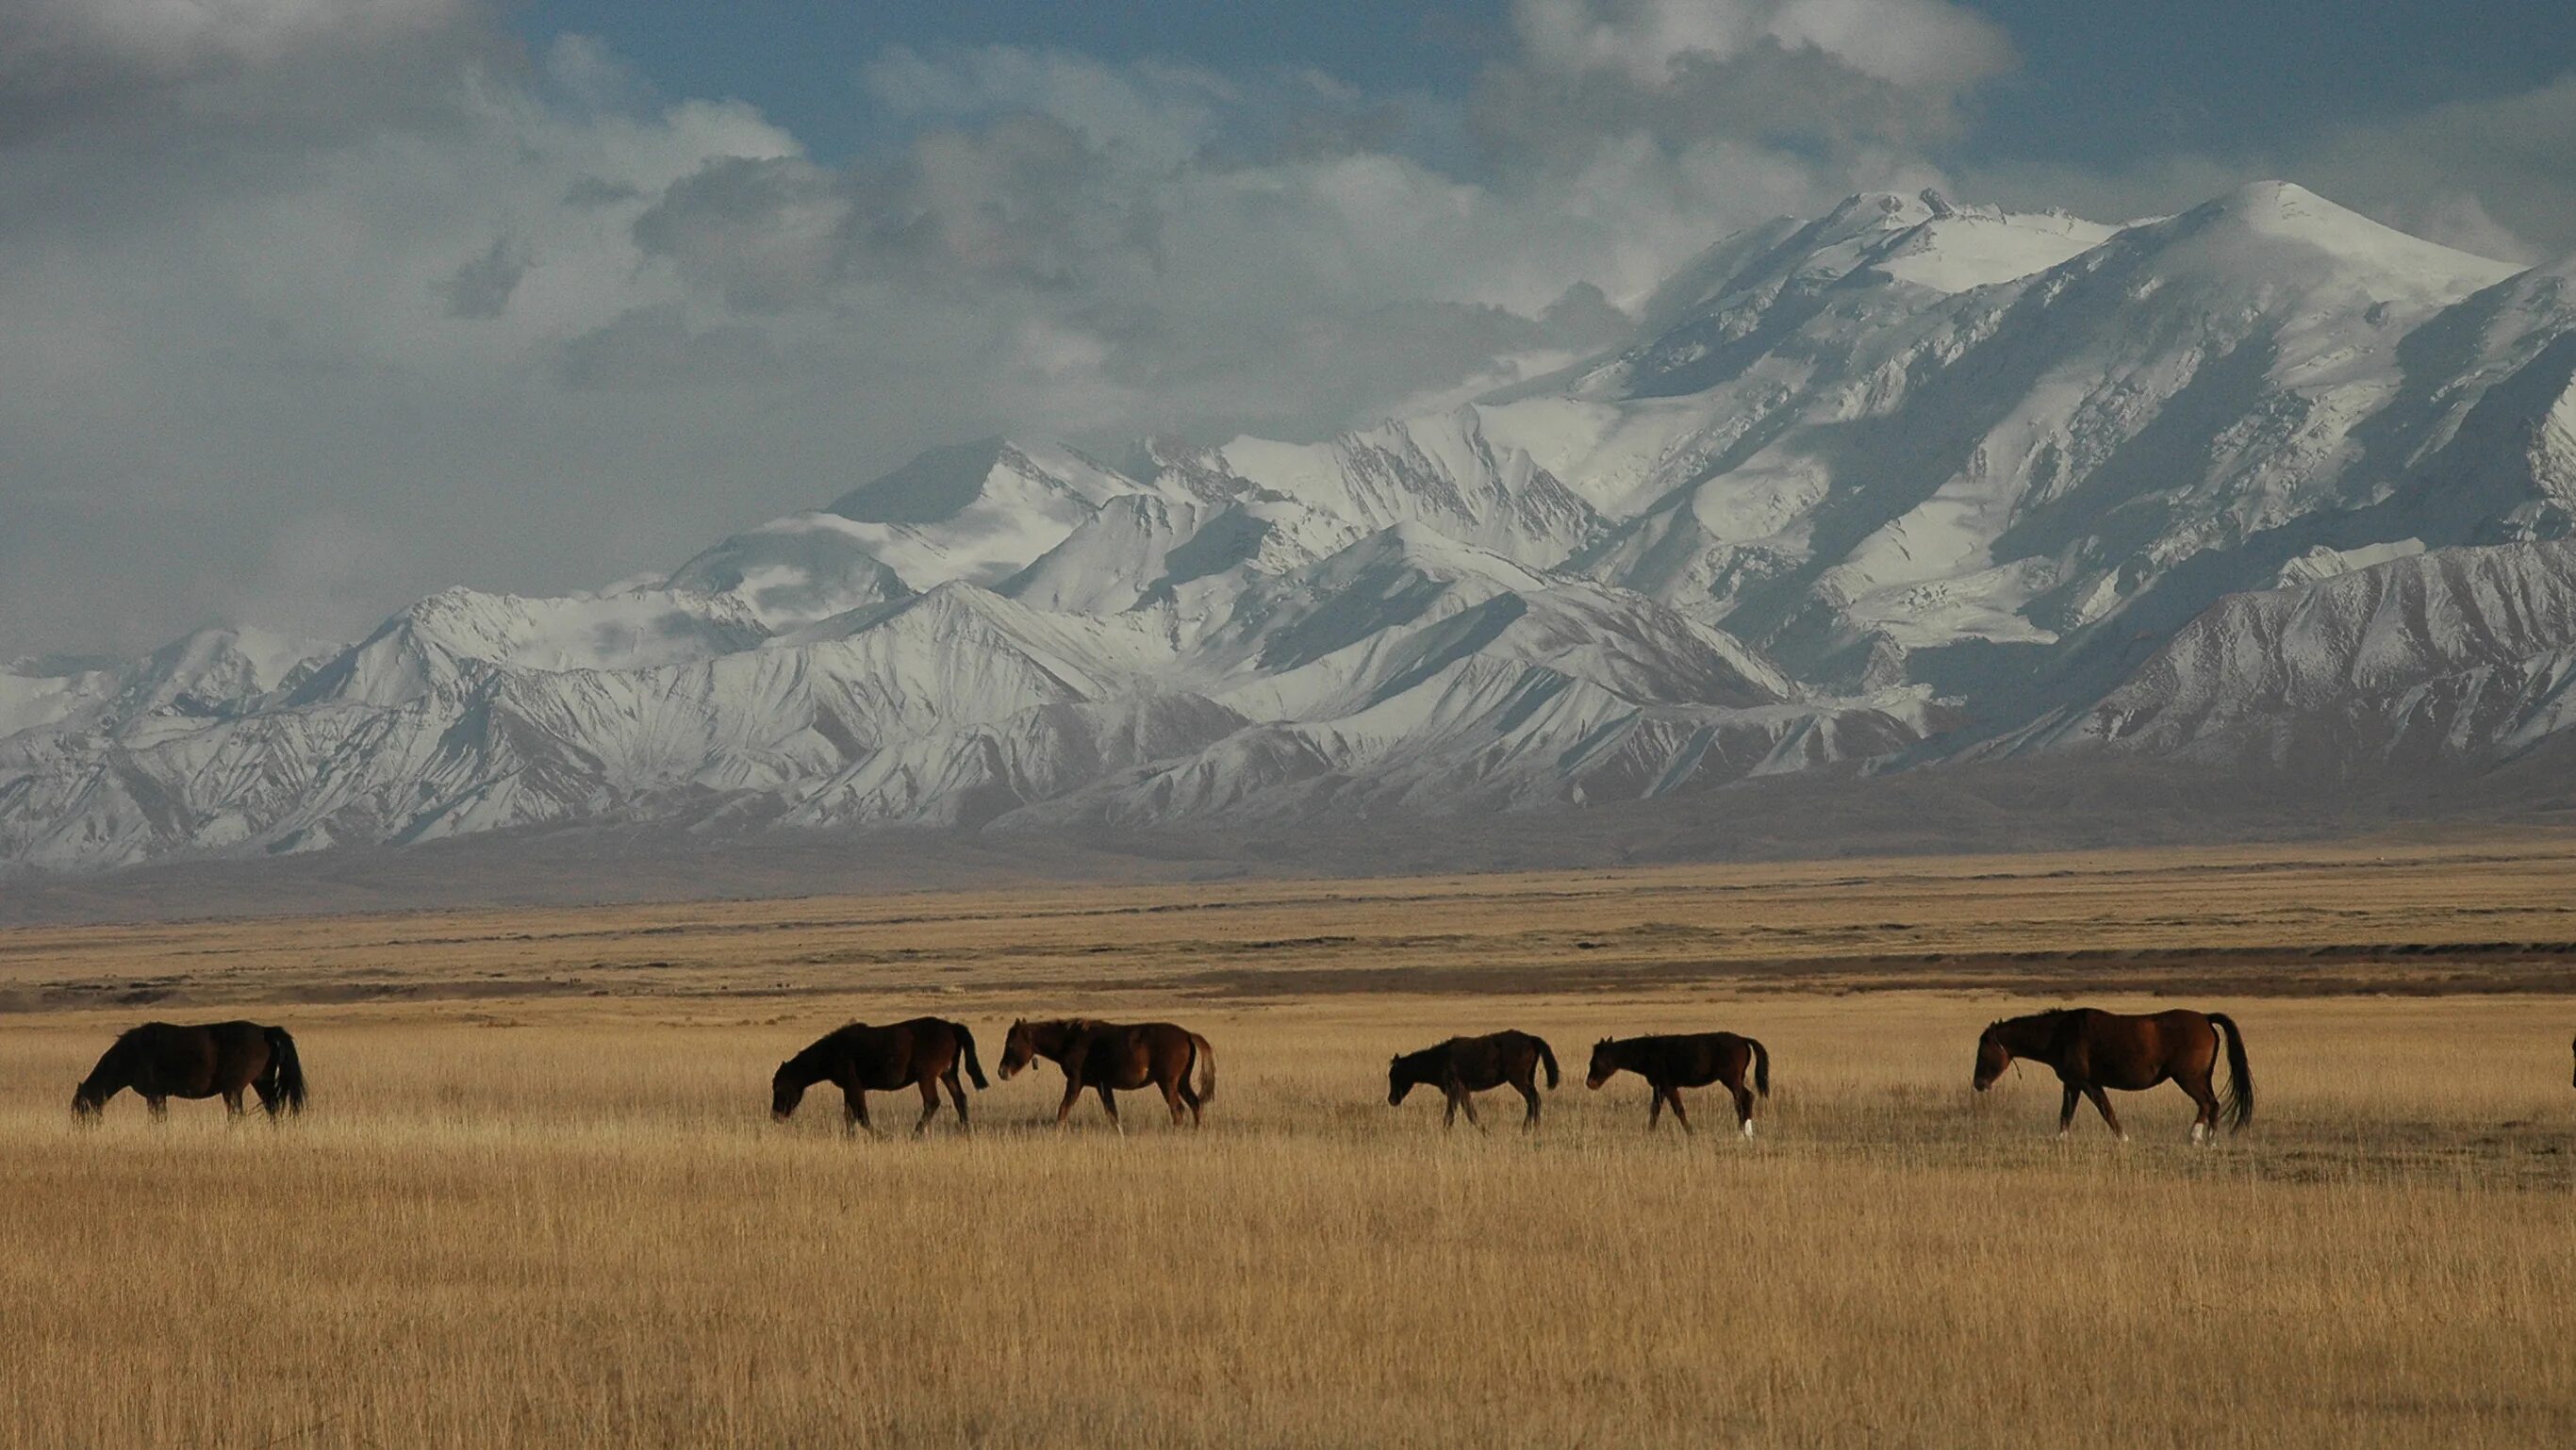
[55,1007,2254,1144]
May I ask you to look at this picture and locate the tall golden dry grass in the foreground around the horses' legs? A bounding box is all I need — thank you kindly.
[0,992,2576,1447]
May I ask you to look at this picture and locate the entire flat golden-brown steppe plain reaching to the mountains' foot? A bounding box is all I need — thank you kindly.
[0,834,2576,1450]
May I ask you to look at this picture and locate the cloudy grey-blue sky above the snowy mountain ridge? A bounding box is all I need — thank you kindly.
[0,0,2576,659]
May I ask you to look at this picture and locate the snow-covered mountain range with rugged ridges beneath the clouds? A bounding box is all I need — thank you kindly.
[0,183,2576,868]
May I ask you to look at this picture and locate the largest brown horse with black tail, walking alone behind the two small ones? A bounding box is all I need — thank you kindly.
[1975,1007,2254,1144]
